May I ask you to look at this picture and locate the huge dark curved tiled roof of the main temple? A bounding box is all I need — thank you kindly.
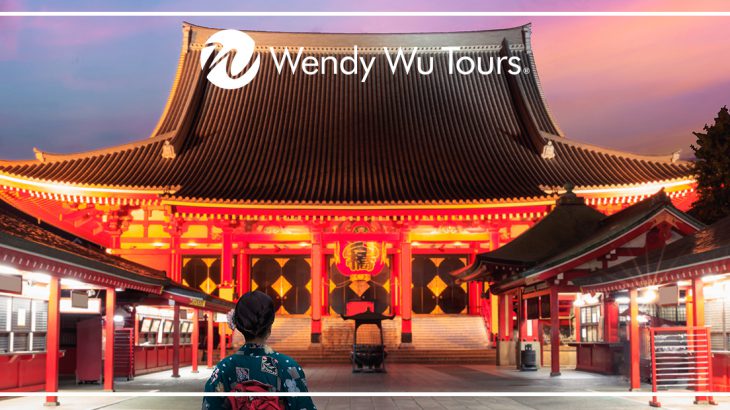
[0,24,691,205]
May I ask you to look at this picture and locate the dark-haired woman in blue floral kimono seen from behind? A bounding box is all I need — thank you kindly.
[203,291,316,410]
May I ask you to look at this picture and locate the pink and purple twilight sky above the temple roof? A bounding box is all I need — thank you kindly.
[0,0,730,159]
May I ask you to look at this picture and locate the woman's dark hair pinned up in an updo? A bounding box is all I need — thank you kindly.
[233,290,276,341]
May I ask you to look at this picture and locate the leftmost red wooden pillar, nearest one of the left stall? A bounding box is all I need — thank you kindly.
[46,276,61,406]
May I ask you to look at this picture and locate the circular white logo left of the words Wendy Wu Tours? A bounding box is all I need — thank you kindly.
[200,30,260,90]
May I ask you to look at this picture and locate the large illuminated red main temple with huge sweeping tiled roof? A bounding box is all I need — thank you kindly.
[0,24,694,362]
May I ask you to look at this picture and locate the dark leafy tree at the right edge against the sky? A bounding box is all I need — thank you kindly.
[690,106,730,224]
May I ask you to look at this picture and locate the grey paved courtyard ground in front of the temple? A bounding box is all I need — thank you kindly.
[0,364,730,410]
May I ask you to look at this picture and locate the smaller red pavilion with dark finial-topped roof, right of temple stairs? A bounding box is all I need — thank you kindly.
[452,186,704,376]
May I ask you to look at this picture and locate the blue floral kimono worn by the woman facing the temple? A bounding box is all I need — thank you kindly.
[203,343,316,410]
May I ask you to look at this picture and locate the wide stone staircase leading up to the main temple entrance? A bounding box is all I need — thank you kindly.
[269,315,495,364]
